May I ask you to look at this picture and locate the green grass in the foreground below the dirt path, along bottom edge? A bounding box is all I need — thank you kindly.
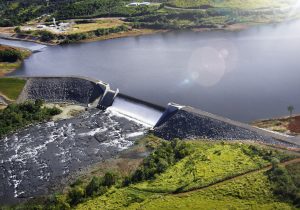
[77,172,293,210]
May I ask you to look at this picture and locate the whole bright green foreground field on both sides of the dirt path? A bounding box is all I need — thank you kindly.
[77,141,297,210]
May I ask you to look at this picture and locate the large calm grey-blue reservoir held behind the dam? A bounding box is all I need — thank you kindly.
[0,21,300,122]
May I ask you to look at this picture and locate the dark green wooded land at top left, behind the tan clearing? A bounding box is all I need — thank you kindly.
[0,0,162,27]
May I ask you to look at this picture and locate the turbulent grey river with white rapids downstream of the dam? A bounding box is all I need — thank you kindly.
[0,109,148,204]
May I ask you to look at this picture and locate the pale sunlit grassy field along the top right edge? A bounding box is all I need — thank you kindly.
[169,0,296,9]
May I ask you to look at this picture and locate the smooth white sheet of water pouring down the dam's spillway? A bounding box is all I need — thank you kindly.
[108,97,162,127]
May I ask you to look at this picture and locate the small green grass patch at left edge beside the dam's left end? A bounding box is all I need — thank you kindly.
[0,78,26,100]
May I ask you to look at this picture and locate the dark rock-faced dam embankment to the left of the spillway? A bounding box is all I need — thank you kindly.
[18,77,106,106]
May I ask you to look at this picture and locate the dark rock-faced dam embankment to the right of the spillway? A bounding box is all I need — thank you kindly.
[154,104,300,147]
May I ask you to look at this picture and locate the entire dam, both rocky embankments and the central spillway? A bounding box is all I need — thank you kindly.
[10,77,300,146]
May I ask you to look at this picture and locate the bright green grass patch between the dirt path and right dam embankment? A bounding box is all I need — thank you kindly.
[135,141,290,192]
